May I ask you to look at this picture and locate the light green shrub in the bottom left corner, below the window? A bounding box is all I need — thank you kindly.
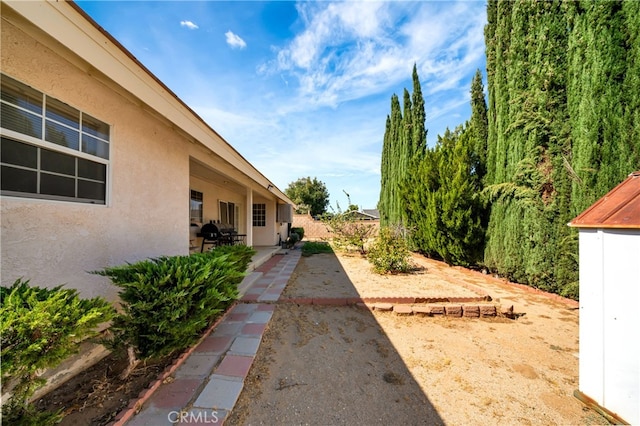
[0,280,114,424]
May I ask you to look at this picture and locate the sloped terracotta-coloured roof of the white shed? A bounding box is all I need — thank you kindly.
[569,171,640,229]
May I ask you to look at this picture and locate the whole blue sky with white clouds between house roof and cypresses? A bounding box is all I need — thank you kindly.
[77,1,486,208]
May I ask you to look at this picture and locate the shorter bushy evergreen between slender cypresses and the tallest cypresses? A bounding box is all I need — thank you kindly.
[405,72,487,265]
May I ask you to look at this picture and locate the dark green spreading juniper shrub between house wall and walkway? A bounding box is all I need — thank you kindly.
[95,246,254,361]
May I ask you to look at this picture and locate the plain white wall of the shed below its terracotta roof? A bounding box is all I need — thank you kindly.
[579,229,640,424]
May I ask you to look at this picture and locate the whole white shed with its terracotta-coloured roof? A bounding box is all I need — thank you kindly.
[569,171,640,424]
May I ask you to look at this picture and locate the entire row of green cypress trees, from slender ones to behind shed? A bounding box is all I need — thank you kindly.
[379,0,640,298]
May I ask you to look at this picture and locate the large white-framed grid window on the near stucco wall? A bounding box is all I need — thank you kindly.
[0,74,110,204]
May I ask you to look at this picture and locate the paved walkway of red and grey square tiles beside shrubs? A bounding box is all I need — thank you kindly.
[121,250,301,426]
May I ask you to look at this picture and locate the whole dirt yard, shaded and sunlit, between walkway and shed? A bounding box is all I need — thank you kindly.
[226,254,608,425]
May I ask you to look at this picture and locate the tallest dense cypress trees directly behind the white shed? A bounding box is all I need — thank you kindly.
[485,1,640,297]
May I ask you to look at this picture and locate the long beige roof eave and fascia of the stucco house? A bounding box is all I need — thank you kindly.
[2,0,293,204]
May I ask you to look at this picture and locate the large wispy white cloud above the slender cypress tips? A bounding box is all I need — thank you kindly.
[259,2,486,109]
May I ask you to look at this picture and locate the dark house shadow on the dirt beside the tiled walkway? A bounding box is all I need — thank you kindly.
[225,254,444,425]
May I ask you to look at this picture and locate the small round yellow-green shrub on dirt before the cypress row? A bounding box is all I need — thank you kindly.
[367,227,411,274]
